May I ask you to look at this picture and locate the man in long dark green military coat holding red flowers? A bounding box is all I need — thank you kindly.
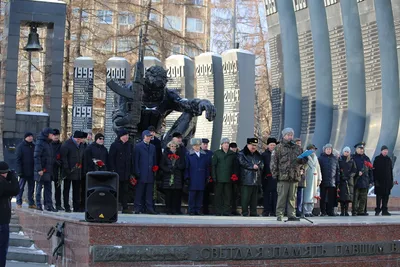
[211,138,239,216]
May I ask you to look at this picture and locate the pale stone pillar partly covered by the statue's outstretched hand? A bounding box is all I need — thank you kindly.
[195,53,224,151]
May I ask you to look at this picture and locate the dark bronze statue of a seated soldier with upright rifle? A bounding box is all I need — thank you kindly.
[107,34,216,146]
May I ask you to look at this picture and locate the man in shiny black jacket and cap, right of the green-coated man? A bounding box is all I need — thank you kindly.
[238,138,264,216]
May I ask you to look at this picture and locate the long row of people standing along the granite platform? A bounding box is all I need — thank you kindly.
[7,127,394,221]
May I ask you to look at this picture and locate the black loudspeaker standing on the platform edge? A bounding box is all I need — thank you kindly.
[85,171,119,223]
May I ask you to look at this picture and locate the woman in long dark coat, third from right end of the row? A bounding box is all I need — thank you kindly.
[339,147,357,216]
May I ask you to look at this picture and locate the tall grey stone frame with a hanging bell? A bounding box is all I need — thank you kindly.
[0,0,66,164]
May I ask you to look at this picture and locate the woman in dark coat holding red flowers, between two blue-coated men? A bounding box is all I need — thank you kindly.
[160,141,186,215]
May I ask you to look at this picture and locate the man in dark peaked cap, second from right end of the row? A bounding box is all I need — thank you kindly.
[352,142,373,216]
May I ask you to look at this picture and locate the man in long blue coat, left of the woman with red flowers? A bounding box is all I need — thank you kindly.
[134,130,158,214]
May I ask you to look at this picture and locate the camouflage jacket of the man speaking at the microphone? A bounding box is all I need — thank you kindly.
[271,140,307,182]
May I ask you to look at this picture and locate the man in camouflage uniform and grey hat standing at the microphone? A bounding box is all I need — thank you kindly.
[271,128,307,221]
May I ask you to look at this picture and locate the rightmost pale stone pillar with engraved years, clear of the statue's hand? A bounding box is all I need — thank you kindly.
[222,49,255,147]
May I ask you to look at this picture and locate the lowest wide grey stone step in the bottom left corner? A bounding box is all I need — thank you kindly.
[7,248,47,263]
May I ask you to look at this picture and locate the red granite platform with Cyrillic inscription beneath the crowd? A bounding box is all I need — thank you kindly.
[16,208,400,267]
